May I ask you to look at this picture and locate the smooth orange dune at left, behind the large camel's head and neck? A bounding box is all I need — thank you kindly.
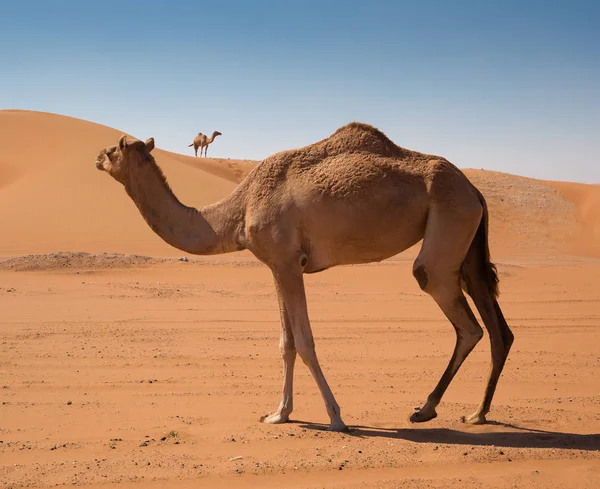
[0,111,241,256]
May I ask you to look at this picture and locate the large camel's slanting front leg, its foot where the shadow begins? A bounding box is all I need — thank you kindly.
[273,265,348,431]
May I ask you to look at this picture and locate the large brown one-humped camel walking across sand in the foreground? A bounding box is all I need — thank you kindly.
[96,122,514,431]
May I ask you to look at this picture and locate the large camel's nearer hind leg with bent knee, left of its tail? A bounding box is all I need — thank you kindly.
[410,200,483,422]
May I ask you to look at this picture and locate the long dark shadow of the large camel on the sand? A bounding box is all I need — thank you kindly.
[291,421,600,451]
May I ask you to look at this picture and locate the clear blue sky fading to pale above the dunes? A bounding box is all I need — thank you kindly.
[0,0,600,183]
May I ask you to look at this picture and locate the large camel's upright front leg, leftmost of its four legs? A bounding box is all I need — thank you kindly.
[261,284,296,424]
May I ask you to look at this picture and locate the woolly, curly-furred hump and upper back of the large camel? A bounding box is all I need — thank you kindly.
[247,122,464,198]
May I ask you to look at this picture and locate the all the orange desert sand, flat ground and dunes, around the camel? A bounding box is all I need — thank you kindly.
[0,110,600,488]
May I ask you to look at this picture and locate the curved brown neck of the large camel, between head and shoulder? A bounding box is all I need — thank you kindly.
[125,157,244,255]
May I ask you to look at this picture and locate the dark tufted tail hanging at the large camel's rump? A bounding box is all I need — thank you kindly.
[461,188,499,299]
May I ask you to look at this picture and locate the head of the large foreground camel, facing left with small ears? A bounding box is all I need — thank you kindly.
[96,136,154,184]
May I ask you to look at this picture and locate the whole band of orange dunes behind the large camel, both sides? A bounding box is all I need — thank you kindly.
[0,110,600,256]
